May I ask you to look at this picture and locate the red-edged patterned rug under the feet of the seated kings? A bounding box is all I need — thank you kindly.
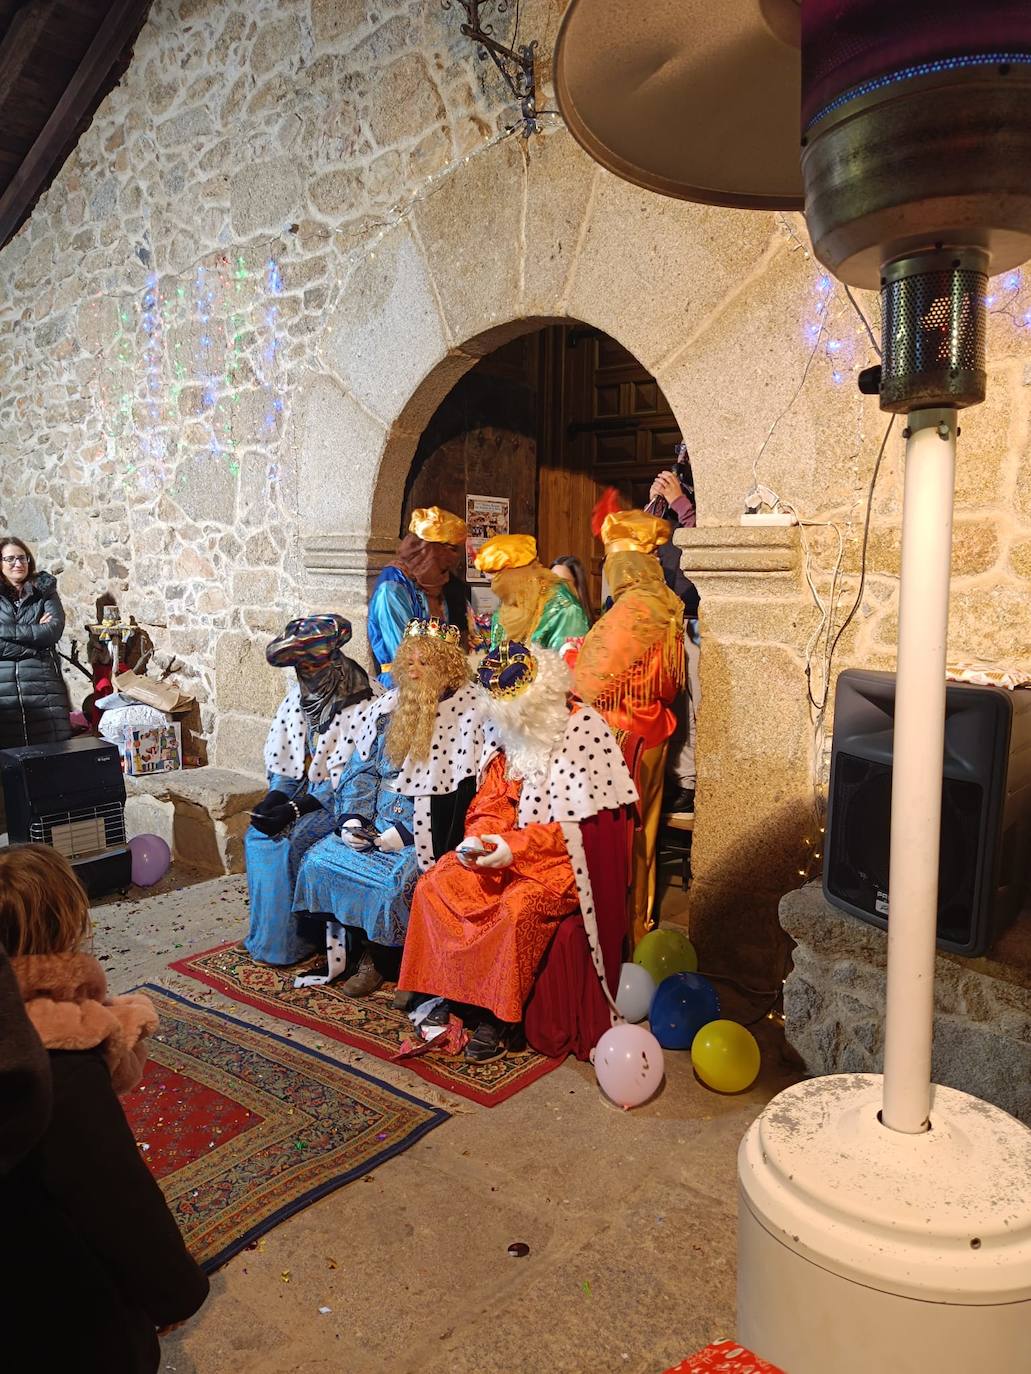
[169,944,562,1107]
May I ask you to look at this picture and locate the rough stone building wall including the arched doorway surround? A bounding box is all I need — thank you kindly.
[0,0,1031,976]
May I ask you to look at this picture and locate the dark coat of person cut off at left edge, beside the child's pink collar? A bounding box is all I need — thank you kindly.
[0,948,49,1170]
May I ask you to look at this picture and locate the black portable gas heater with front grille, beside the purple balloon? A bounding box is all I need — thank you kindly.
[0,735,132,897]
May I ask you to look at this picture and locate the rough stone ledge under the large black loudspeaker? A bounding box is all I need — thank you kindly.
[781,883,1031,1125]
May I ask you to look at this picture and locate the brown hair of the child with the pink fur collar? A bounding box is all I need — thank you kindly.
[0,845,89,956]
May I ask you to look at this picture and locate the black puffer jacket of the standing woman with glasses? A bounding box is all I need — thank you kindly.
[0,573,71,749]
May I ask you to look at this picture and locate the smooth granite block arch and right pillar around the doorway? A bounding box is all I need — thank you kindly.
[294,132,811,978]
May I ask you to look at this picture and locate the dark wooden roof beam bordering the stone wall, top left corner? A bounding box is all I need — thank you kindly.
[0,0,151,247]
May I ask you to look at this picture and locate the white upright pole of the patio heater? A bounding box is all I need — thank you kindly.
[881,409,957,1135]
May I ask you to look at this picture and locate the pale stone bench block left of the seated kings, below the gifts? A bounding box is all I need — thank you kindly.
[125,767,267,874]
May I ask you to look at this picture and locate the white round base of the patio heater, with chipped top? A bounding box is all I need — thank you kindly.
[737,1074,1031,1374]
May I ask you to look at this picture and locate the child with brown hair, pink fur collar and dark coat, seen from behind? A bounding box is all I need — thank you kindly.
[0,845,208,1374]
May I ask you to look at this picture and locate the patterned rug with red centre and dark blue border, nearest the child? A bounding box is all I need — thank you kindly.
[122,984,448,1272]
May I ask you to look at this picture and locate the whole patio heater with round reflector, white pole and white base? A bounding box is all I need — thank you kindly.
[555,0,1031,1374]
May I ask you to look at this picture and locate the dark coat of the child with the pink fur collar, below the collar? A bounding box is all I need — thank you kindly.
[0,1047,208,1374]
